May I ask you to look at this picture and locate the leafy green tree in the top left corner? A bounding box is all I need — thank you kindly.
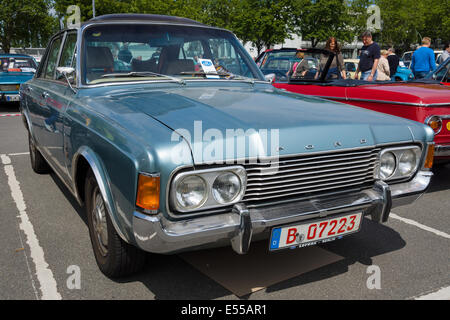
[0,0,57,53]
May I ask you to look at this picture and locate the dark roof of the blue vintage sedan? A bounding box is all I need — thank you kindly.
[83,13,206,26]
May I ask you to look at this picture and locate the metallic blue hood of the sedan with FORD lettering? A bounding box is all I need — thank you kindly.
[79,82,432,164]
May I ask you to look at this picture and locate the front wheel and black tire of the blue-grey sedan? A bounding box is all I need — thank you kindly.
[84,170,146,278]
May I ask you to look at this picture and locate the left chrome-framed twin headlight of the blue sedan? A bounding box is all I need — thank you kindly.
[170,166,247,213]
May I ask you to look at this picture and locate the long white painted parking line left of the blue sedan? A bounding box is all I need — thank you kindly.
[0,154,62,300]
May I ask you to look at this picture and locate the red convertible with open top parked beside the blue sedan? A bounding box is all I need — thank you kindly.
[269,49,450,162]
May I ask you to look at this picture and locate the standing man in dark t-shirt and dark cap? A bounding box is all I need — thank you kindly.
[355,31,381,81]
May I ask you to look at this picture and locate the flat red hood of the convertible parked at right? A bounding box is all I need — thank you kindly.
[346,83,450,105]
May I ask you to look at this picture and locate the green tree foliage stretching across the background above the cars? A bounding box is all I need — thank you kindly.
[0,0,450,51]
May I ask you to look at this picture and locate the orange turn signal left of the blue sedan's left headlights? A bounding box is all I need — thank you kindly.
[136,174,160,213]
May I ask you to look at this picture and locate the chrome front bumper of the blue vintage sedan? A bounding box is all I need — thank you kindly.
[133,171,433,254]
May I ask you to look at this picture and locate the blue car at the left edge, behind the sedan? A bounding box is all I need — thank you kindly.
[0,54,37,102]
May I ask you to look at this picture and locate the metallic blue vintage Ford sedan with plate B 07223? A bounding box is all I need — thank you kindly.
[20,15,434,277]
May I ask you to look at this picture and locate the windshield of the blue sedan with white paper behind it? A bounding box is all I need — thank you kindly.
[82,24,264,84]
